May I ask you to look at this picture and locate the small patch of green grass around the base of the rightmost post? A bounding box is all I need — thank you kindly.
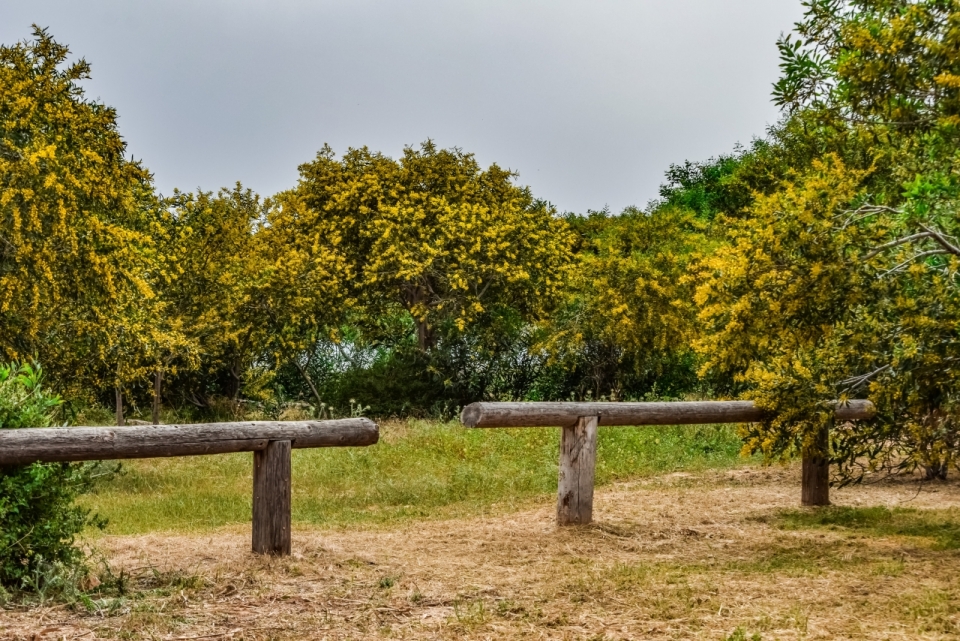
[774,507,960,550]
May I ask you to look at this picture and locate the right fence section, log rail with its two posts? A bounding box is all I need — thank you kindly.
[460,400,876,525]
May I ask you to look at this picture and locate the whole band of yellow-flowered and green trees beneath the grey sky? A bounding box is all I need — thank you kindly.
[0,0,960,480]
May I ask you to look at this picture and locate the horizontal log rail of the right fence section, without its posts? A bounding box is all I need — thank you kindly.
[460,400,875,427]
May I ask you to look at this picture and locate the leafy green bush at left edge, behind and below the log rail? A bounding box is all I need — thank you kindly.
[0,363,103,589]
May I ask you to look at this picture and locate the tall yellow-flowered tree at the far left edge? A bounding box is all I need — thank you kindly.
[0,27,169,402]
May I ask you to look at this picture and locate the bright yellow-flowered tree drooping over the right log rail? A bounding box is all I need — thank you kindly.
[695,156,875,496]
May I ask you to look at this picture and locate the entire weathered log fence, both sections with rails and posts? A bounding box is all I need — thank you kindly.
[0,400,875,555]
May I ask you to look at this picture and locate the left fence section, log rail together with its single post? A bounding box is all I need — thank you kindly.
[0,418,380,555]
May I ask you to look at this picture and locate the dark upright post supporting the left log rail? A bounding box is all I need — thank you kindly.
[253,441,291,556]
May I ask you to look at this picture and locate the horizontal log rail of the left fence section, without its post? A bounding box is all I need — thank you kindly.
[0,418,379,465]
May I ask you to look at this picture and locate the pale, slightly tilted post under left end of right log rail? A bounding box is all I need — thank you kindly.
[557,416,598,525]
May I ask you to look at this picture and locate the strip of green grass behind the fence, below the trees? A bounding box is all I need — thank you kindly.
[84,421,740,534]
